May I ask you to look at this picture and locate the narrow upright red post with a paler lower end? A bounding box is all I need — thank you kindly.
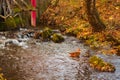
[31,0,36,27]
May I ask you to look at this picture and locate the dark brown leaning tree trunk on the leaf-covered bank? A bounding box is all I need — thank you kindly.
[85,0,106,32]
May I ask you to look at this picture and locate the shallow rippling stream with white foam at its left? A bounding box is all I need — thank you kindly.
[0,29,120,80]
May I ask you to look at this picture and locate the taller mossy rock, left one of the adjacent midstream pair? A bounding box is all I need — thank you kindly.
[41,27,53,41]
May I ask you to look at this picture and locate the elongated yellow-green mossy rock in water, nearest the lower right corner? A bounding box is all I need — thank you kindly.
[89,56,115,72]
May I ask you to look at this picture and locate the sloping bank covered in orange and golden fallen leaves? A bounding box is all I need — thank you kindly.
[40,0,120,55]
